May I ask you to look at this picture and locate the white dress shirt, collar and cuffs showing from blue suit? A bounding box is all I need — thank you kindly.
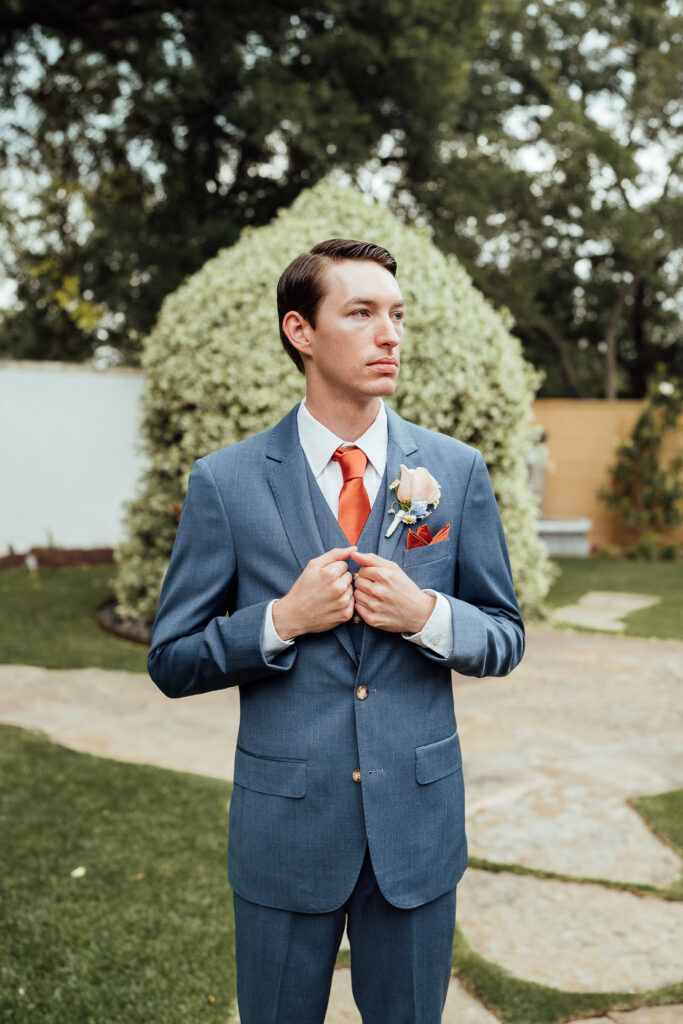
[261,398,453,658]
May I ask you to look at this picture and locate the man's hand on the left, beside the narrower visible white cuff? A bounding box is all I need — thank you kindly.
[272,544,358,640]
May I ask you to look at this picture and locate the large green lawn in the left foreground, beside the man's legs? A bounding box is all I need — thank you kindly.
[0,726,234,1024]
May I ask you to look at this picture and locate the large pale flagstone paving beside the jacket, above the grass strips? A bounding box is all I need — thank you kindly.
[455,630,683,886]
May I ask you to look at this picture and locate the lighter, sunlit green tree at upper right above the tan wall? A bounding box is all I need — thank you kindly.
[392,0,683,397]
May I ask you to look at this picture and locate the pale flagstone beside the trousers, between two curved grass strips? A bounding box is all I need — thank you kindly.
[458,868,683,992]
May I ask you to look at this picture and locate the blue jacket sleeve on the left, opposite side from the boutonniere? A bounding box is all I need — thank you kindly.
[147,460,296,697]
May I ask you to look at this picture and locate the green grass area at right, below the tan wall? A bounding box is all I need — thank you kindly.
[548,558,683,640]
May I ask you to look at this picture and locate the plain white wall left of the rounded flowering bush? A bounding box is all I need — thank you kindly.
[0,360,144,554]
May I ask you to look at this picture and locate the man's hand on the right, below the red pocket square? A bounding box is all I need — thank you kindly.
[353,551,436,634]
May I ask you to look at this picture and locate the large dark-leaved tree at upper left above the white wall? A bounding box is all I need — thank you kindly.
[0,0,483,359]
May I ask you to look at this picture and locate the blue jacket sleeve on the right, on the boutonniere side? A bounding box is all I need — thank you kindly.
[421,452,524,676]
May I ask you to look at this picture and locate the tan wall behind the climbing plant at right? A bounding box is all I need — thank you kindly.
[532,398,683,545]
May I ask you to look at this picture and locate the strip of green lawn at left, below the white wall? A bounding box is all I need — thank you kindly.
[0,565,147,672]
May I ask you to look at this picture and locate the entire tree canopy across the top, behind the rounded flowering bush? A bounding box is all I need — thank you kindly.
[0,0,683,395]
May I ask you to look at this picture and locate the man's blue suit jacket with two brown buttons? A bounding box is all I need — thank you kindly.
[148,407,524,912]
